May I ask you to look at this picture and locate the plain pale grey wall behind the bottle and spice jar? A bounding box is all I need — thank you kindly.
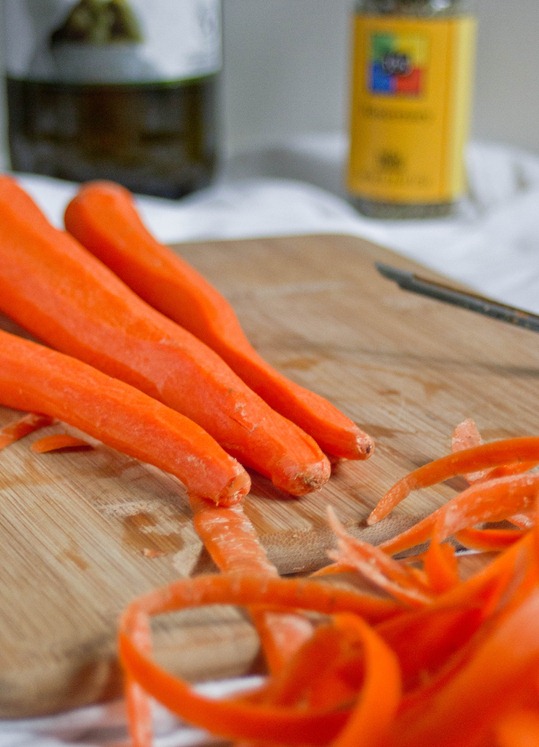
[0,0,539,167]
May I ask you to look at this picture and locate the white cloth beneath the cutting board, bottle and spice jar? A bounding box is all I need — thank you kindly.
[0,134,539,747]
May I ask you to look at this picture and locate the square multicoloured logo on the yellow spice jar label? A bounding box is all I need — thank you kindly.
[369,31,428,96]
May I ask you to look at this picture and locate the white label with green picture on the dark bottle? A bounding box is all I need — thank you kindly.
[3,0,221,84]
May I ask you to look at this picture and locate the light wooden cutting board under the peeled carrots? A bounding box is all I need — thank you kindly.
[0,236,539,717]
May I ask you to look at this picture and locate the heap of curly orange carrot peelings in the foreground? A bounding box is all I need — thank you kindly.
[119,422,539,747]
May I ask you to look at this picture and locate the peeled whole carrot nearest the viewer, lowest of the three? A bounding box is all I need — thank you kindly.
[0,330,250,504]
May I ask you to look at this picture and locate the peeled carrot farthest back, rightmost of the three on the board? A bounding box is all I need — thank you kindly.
[65,182,373,459]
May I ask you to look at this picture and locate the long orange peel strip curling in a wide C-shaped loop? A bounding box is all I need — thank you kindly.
[118,573,395,745]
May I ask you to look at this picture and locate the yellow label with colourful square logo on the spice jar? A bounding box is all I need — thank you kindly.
[348,16,475,204]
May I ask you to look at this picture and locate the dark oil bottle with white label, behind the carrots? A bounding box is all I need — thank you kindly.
[3,0,222,198]
